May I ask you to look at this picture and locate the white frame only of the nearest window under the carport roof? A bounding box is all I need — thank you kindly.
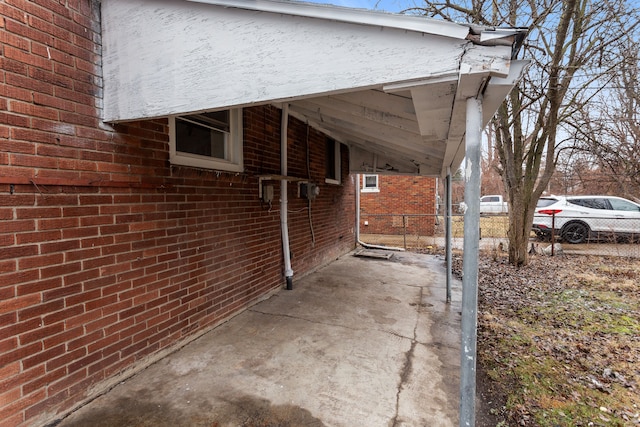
[169,108,244,172]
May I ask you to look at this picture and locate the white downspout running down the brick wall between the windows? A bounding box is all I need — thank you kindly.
[280,104,293,290]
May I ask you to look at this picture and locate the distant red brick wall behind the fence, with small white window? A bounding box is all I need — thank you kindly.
[360,175,437,236]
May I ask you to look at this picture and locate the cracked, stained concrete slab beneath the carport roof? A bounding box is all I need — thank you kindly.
[59,252,461,427]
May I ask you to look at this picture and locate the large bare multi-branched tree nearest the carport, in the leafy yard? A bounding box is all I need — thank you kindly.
[412,0,639,266]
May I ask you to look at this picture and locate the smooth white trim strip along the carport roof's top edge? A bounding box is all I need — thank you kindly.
[188,0,469,40]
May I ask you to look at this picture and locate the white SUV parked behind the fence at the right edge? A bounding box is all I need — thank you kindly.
[532,196,640,243]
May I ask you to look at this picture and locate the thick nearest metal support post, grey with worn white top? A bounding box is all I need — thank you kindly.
[460,97,482,427]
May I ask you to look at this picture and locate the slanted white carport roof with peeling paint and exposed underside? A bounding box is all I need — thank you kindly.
[102,0,525,176]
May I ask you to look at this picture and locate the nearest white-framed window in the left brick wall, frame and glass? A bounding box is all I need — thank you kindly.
[169,109,244,172]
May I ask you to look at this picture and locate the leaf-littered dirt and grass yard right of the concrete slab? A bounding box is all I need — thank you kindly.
[454,253,640,427]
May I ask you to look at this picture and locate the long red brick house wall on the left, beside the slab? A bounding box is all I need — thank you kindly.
[0,0,355,426]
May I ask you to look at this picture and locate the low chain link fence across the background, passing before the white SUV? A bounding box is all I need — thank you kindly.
[360,213,640,258]
